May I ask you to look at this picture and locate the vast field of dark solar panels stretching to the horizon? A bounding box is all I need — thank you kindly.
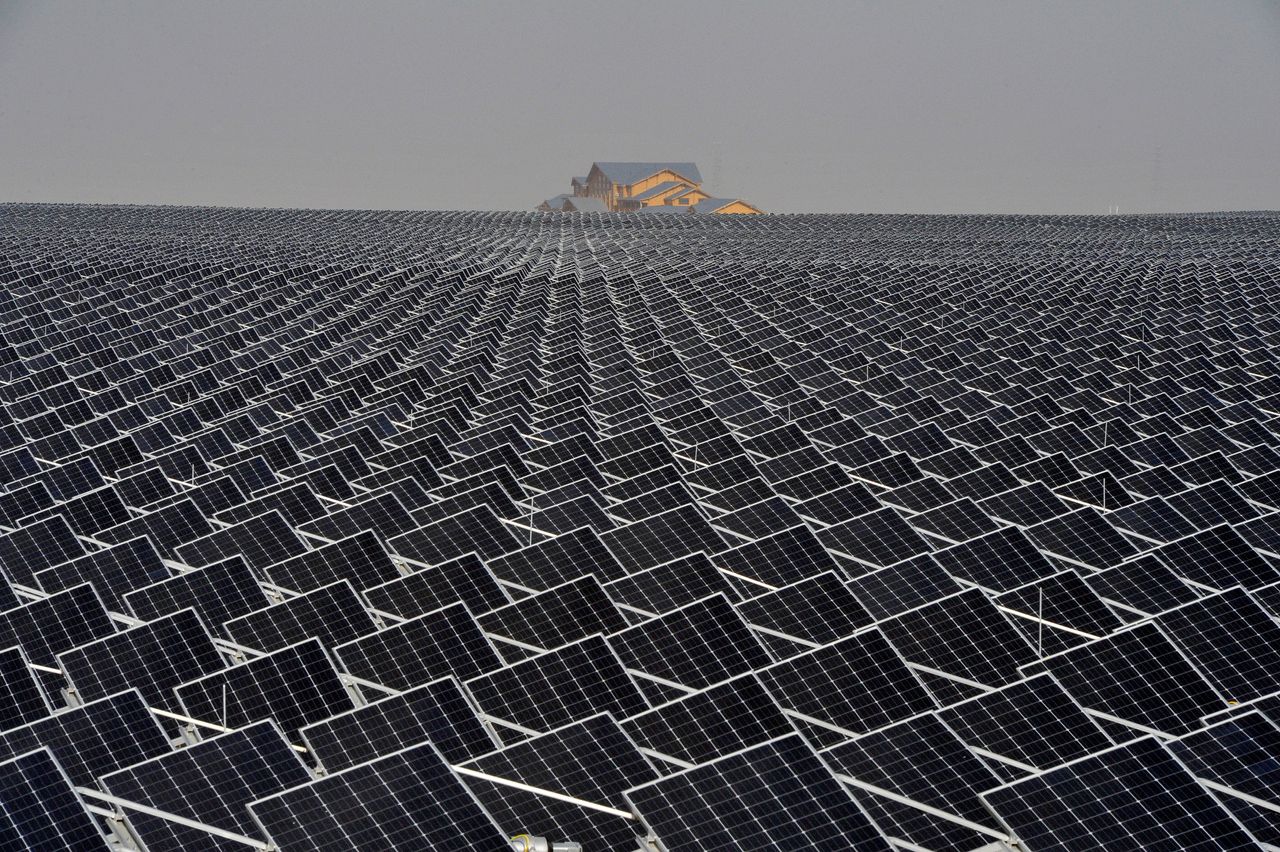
[0,205,1280,852]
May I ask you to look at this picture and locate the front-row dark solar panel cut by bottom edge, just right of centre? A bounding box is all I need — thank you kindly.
[626,734,892,852]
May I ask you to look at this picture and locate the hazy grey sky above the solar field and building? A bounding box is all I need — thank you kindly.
[0,0,1280,212]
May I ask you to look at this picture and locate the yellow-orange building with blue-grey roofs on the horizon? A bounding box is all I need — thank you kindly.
[538,162,763,215]
